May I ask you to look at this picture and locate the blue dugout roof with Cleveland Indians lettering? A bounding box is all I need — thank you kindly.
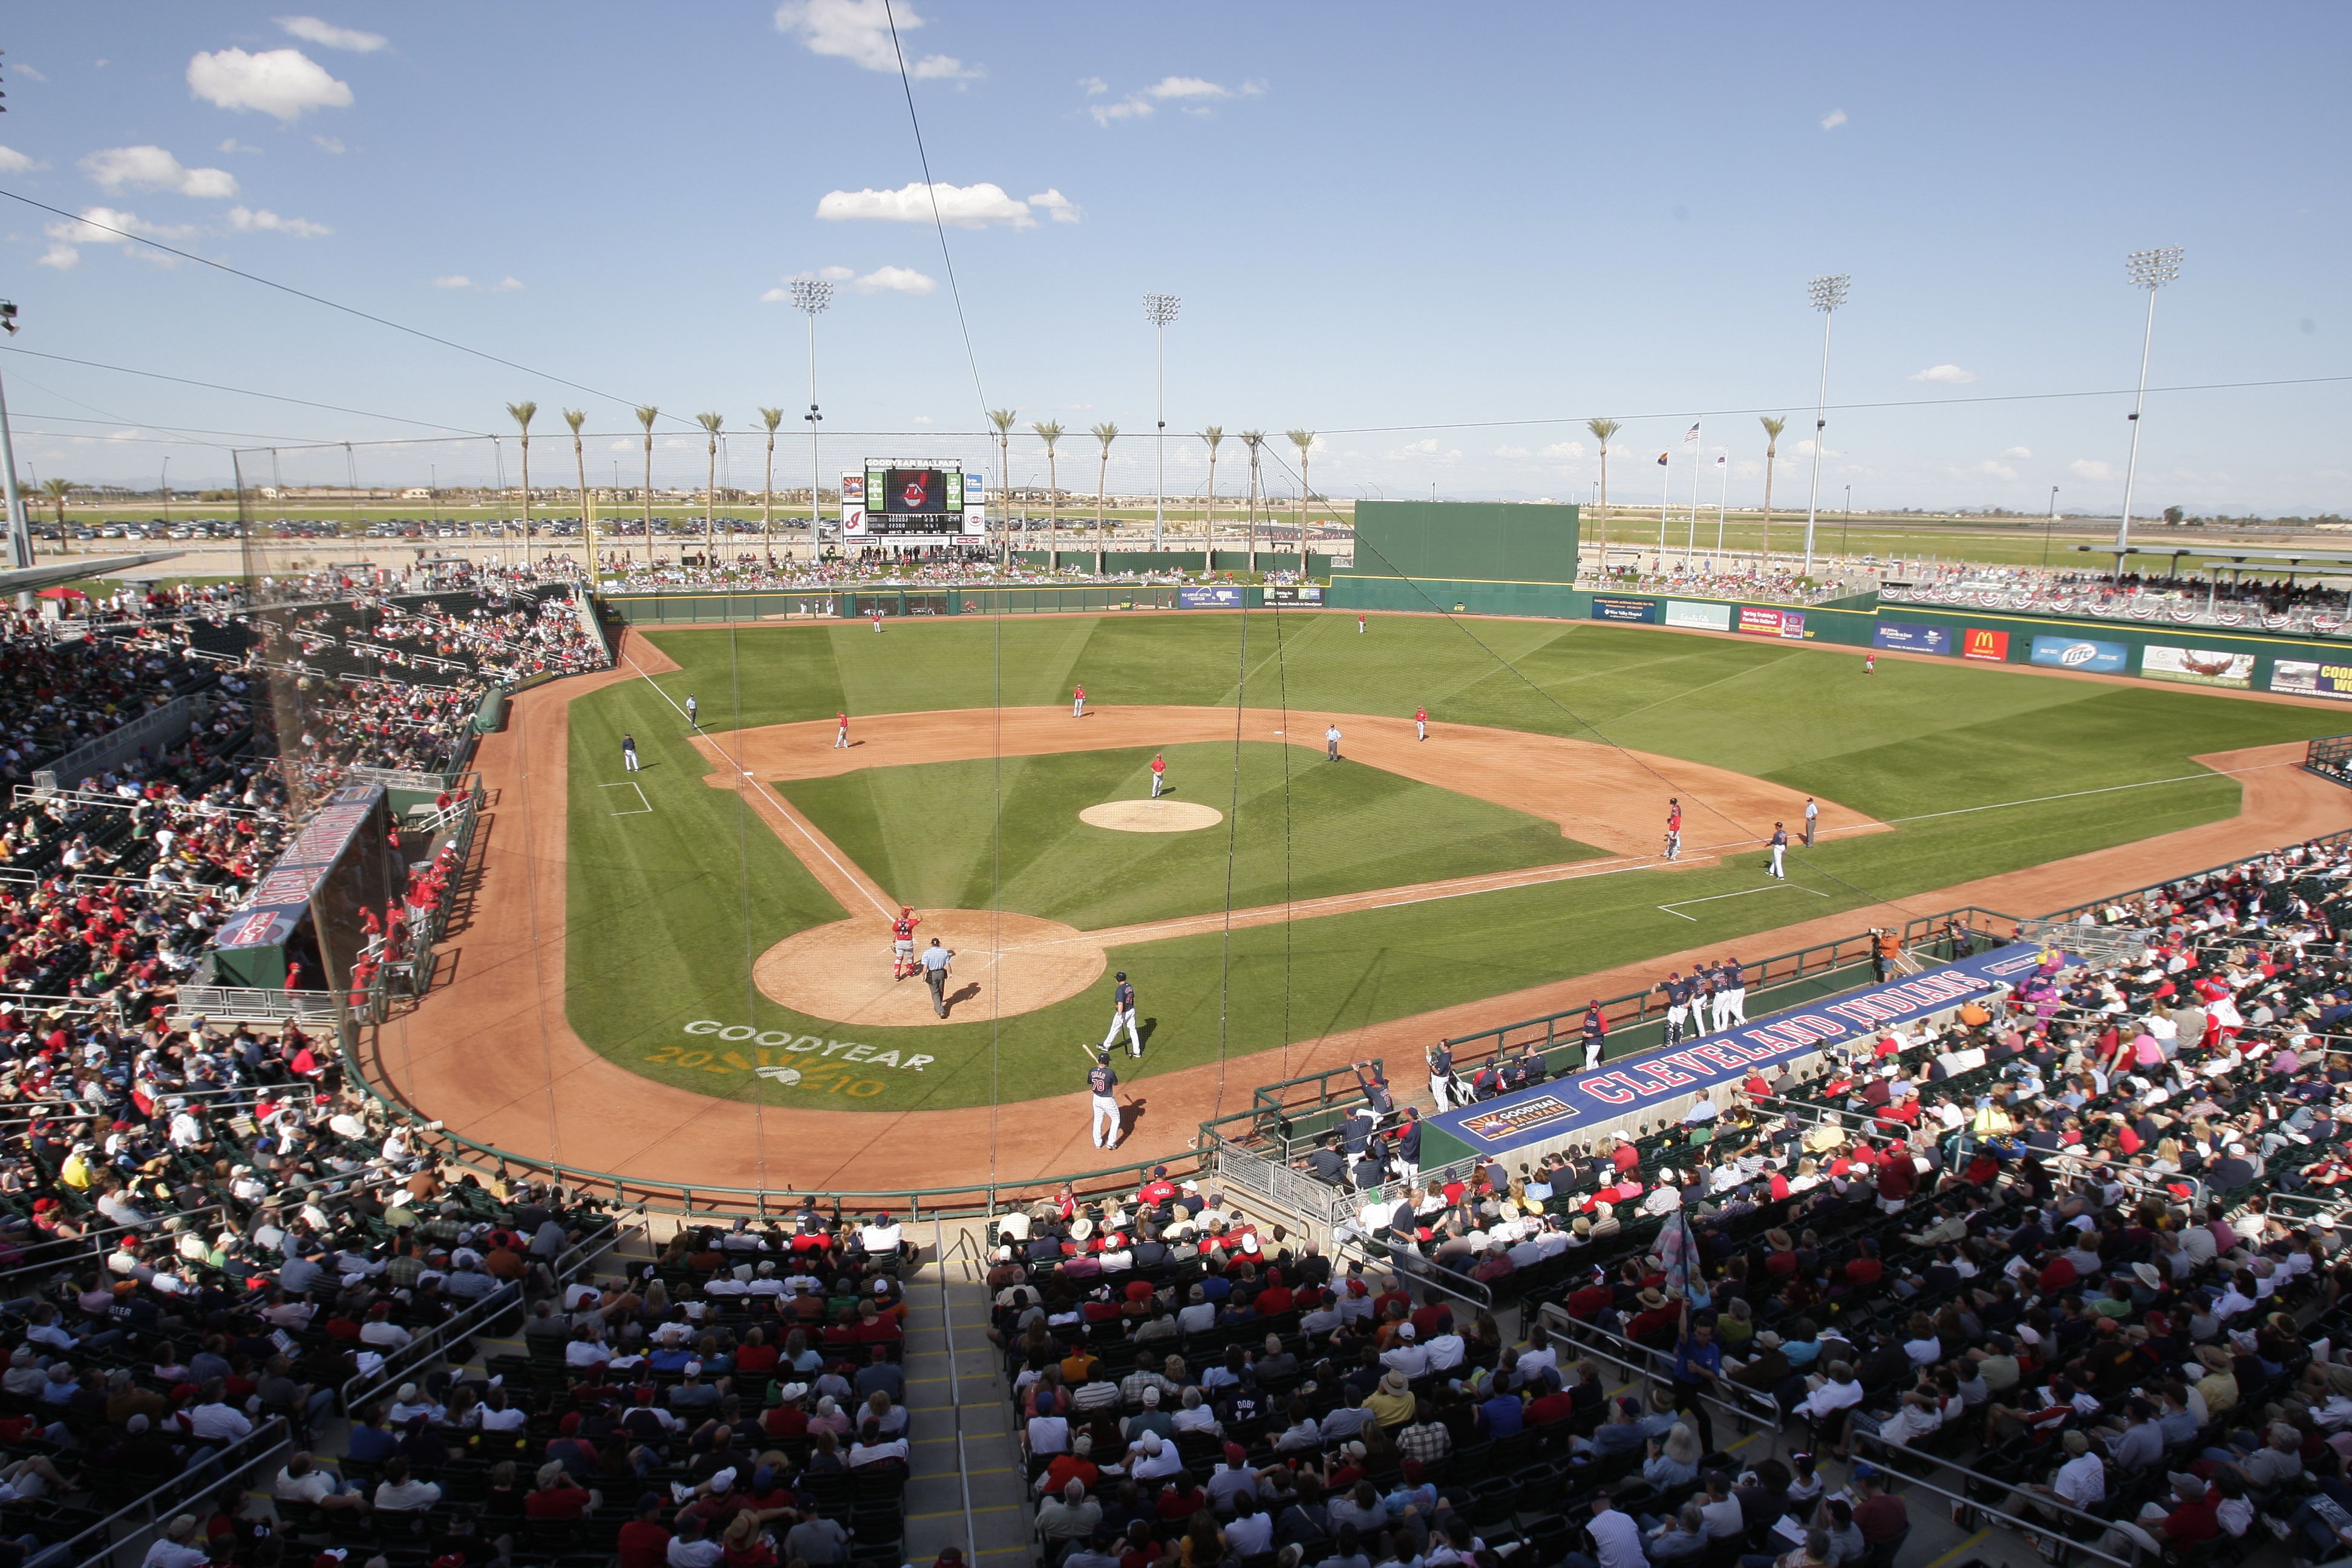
[1428,942,2042,1154]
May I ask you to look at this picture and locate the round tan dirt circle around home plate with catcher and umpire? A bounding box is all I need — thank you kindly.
[753,910,1103,1027]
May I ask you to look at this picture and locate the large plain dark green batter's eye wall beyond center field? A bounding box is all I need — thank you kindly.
[1324,501,1581,618]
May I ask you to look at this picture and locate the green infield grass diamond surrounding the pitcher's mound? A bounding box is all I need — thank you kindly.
[781,740,1602,931]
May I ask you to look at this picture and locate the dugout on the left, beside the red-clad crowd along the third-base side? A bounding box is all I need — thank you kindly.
[195,783,407,990]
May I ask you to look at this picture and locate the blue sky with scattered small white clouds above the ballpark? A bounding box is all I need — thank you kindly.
[0,0,2352,512]
